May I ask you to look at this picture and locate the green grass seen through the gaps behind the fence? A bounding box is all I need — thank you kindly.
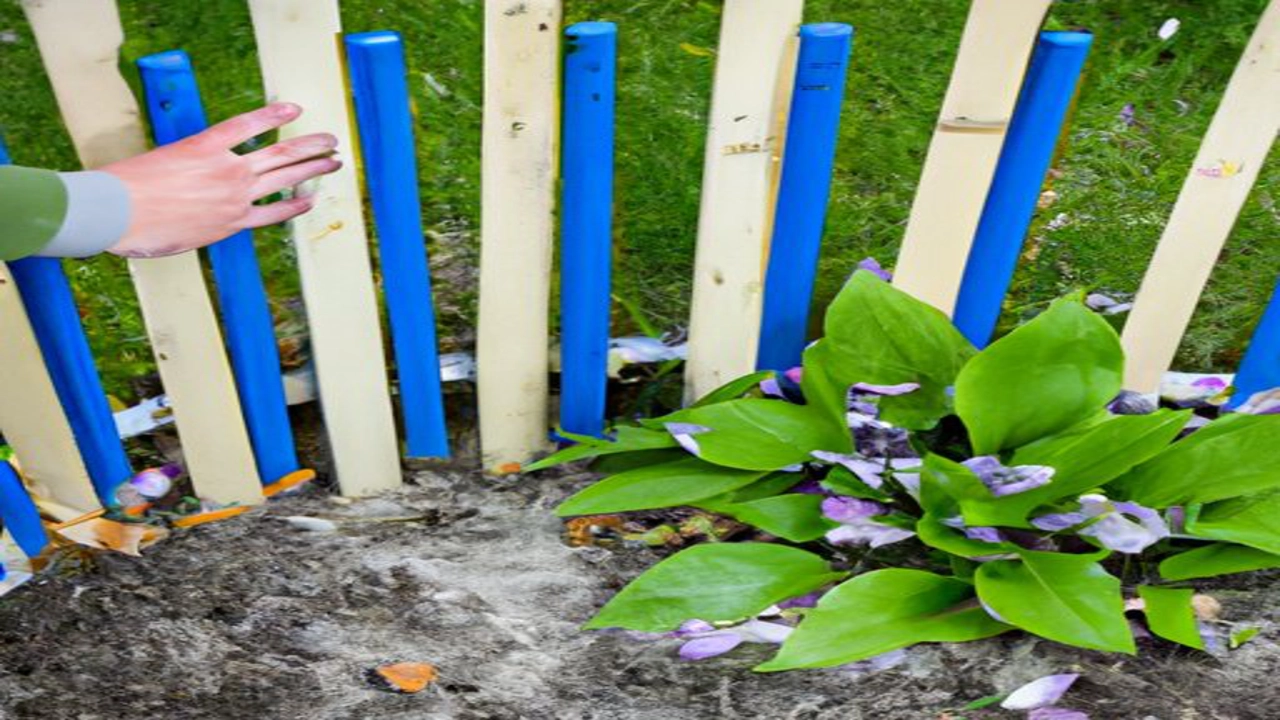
[0,0,1280,395]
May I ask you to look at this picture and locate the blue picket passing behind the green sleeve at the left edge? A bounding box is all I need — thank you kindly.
[0,135,133,505]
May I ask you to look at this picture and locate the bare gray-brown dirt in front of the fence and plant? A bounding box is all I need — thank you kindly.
[0,471,1280,720]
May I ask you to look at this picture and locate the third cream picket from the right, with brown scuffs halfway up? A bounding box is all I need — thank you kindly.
[685,0,804,401]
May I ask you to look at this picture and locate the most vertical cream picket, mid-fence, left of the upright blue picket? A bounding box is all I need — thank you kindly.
[476,0,562,471]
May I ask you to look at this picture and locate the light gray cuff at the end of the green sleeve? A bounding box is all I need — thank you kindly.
[36,170,131,258]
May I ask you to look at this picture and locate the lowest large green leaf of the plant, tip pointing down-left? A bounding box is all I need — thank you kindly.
[756,569,1011,671]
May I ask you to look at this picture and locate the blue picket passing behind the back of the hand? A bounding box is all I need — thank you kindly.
[138,50,298,484]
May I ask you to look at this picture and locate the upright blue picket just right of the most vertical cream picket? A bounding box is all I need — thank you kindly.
[559,22,618,437]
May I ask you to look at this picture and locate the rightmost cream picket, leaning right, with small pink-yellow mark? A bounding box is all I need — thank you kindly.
[1121,0,1280,392]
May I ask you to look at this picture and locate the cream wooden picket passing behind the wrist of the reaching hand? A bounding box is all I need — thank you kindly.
[23,0,262,503]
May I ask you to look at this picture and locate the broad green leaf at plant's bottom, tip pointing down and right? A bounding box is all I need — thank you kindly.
[975,551,1135,653]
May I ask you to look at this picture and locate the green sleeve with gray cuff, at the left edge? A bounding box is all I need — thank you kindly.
[0,165,129,260]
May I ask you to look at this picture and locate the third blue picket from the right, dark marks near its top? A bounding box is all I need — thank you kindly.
[755,23,854,372]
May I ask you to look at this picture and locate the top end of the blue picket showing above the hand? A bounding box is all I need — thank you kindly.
[138,50,209,145]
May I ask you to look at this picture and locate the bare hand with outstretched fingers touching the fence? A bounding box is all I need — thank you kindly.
[99,102,342,258]
